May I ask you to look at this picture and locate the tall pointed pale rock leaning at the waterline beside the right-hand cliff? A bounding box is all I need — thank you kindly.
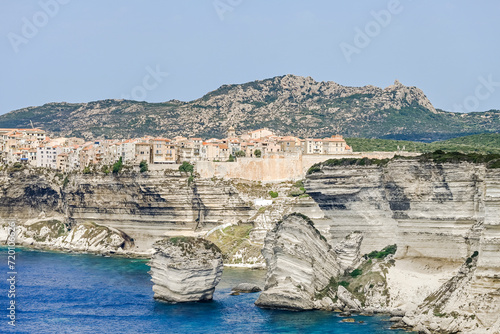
[255,213,341,310]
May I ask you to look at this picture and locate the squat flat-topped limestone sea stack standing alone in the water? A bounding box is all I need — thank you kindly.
[148,236,223,303]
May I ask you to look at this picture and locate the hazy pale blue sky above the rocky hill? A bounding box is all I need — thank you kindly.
[0,0,500,113]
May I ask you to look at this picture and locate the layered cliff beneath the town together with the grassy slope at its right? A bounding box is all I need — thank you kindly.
[0,168,298,267]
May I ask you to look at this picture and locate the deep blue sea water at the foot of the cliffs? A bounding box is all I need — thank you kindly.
[0,248,410,334]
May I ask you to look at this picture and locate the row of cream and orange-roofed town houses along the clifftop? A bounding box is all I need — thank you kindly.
[0,128,352,171]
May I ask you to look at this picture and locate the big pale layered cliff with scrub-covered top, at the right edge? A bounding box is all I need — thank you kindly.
[306,160,500,333]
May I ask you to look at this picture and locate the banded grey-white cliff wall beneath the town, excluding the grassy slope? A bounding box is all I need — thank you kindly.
[0,169,252,251]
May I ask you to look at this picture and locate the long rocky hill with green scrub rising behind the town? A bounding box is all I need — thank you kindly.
[0,75,500,141]
